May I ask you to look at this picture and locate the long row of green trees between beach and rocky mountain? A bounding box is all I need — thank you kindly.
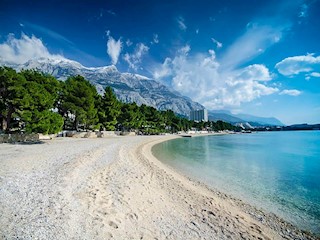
[0,67,235,134]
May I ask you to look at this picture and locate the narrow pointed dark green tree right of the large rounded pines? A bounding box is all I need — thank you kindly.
[98,87,121,131]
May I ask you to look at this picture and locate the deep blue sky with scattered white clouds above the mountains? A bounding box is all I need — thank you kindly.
[0,0,320,124]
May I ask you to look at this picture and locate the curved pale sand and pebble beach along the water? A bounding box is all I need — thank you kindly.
[0,137,316,239]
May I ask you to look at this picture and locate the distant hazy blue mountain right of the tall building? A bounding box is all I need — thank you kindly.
[208,110,284,128]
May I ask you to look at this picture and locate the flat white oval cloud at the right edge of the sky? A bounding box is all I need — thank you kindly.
[276,54,320,77]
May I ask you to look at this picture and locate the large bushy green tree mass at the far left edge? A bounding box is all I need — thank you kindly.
[0,67,63,133]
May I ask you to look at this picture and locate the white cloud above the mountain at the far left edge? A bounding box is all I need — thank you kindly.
[0,33,65,64]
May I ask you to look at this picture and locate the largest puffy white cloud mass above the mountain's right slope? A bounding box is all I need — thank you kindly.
[153,45,279,109]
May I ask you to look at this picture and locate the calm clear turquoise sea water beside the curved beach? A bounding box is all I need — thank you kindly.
[152,131,320,234]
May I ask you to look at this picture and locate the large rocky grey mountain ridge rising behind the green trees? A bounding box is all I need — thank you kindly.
[3,58,204,116]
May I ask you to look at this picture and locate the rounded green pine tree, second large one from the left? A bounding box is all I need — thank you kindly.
[58,76,98,131]
